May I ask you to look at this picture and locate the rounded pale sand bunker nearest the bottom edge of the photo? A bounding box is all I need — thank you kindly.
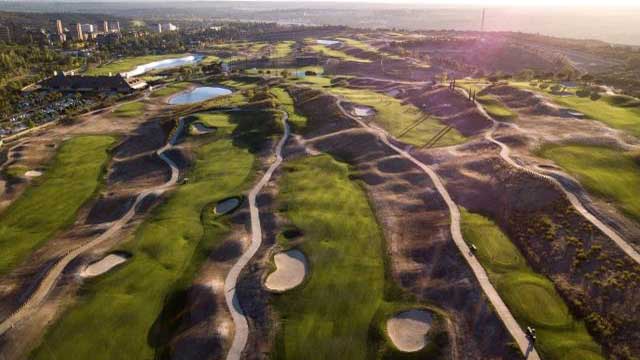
[387,310,432,352]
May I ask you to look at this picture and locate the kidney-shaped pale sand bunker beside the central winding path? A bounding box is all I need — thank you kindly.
[264,250,307,291]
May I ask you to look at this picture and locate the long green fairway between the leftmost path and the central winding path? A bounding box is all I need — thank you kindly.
[32,124,254,360]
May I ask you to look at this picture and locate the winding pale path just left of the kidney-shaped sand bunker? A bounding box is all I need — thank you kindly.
[224,111,290,360]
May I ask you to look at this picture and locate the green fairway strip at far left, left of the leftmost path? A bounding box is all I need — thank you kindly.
[0,136,114,274]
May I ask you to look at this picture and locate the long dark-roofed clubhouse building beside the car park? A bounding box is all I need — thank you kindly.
[40,73,147,93]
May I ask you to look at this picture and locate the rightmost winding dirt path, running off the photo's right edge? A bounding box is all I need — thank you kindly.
[460,89,640,264]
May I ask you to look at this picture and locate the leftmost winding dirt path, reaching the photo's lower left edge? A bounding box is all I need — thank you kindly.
[0,119,184,335]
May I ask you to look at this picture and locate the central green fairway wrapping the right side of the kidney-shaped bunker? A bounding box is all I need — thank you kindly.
[273,156,385,359]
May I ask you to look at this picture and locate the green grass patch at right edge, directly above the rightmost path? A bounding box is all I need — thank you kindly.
[540,145,640,222]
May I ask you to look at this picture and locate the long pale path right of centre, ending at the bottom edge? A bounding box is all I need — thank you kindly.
[337,100,540,360]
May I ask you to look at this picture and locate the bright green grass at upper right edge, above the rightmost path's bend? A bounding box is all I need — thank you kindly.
[510,82,640,137]
